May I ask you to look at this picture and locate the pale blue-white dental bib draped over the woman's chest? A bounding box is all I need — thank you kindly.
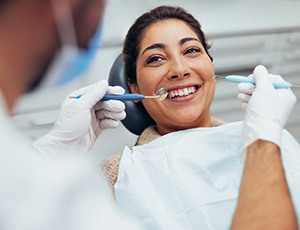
[115,122,300,230]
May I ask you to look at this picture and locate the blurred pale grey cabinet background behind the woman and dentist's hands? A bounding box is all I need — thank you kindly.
[13,0,300,162]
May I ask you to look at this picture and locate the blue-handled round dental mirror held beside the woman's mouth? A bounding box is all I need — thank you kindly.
[70,88,168,101]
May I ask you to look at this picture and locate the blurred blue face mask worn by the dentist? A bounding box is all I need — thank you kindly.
[41,0,102,88]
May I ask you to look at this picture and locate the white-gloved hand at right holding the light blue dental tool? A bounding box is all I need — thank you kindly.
[238,66,297,162]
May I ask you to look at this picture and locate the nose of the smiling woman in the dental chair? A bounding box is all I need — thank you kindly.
[169,58,190,79]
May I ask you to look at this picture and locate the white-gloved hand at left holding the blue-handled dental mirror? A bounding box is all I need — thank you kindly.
[33,81,126,154]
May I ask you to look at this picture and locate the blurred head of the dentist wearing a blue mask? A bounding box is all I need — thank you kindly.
[0,0,105,111]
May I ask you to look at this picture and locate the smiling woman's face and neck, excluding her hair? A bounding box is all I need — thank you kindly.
[131,19,215,135]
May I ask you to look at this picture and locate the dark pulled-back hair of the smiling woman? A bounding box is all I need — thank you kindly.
[123,6,213,83]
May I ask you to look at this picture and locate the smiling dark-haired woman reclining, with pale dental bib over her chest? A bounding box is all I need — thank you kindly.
[103,6,299,229]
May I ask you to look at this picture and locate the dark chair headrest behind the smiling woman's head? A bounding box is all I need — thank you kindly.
[108,54,154,135]
